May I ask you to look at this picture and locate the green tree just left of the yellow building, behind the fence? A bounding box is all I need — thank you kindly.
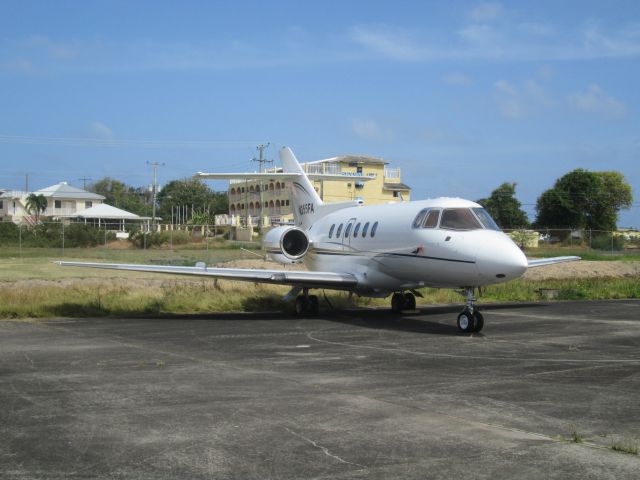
[158,178,229,222]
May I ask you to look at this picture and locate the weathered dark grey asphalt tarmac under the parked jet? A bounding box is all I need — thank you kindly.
[0,300,640,479]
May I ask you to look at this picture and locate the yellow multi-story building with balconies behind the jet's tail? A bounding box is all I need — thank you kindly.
[228,155,411,225]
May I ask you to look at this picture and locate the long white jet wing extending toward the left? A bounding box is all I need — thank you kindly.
[55,261,358,290]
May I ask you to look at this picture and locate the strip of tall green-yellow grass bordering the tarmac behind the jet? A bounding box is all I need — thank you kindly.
[0,274,640,318]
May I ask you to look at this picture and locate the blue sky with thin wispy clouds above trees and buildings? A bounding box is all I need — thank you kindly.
[0,0,640,227]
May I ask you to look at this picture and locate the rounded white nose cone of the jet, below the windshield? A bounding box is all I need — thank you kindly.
[477,233,528,282]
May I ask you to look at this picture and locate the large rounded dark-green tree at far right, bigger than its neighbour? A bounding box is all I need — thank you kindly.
[535,168,633,230]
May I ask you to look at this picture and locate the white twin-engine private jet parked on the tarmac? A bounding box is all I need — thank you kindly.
[58,147,580,333]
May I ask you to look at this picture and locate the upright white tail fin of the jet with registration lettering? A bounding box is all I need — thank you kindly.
[280,147,323,229]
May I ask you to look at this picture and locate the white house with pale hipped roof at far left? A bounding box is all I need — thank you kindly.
[0,182,104,223]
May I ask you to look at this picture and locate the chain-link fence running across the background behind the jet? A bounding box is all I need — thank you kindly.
[0,222,640,258]
